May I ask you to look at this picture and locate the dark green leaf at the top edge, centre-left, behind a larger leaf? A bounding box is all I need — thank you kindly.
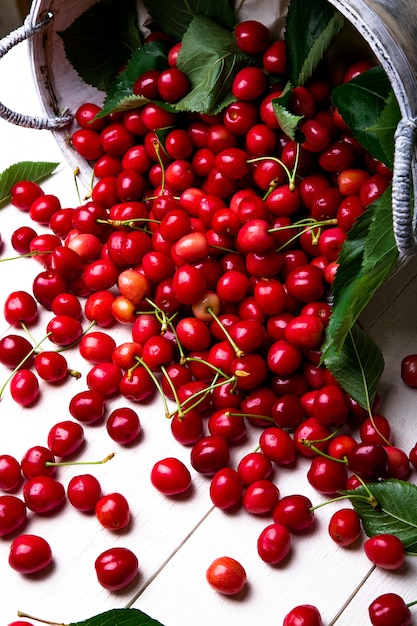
[144,0,235,41]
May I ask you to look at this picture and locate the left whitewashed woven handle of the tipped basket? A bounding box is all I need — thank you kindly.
[0,13,72,130]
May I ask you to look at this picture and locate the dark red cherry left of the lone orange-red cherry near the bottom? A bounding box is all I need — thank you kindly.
[94,547,139,591]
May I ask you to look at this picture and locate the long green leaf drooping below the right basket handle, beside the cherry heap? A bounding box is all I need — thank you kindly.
[323,187,398,362]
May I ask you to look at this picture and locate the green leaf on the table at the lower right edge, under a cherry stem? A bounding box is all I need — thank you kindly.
[343,479,417,552]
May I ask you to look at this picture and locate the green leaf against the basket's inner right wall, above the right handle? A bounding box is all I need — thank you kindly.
[333,66,401,168]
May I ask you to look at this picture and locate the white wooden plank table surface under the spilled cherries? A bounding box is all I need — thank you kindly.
[0,35,417,626]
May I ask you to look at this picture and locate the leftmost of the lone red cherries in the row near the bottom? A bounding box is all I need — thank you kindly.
[9,534,52,574]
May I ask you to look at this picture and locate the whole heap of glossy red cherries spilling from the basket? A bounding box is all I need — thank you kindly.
[0,20,417,626]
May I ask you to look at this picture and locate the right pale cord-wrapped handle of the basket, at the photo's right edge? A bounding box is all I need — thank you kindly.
[392,118,417,257]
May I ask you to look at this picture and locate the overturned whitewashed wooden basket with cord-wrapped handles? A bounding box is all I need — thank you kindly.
[0,0,417,258]
